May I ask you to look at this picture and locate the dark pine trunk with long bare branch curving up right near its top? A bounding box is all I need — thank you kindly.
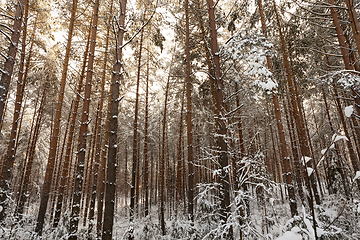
[102,0,127,240]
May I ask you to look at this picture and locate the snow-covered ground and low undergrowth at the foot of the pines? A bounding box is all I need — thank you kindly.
[0,186,360,240]
